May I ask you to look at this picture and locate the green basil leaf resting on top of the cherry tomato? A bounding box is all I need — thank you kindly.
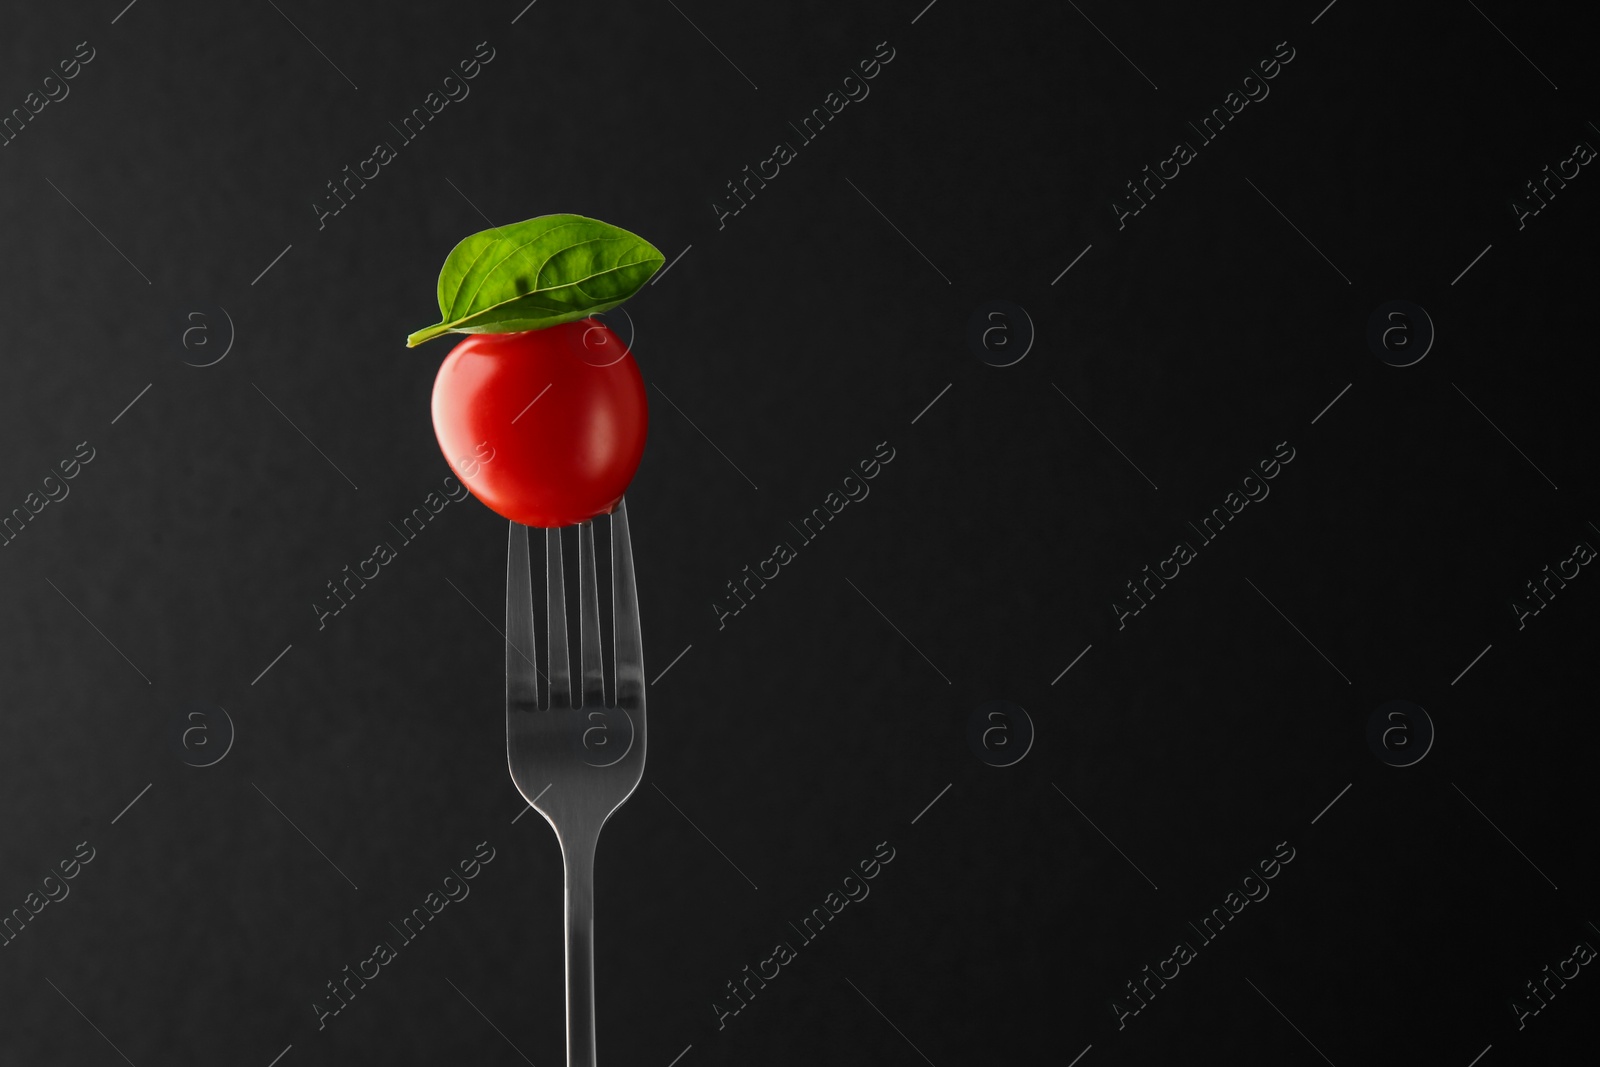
[406,214,666,349]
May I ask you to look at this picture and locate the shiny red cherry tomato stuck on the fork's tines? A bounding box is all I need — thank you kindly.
[434,318,648,526]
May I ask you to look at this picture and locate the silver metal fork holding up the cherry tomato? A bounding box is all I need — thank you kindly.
[506,502,645,1067]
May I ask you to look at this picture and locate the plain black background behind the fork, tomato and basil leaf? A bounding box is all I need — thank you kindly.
[0,0,1600,1067]
